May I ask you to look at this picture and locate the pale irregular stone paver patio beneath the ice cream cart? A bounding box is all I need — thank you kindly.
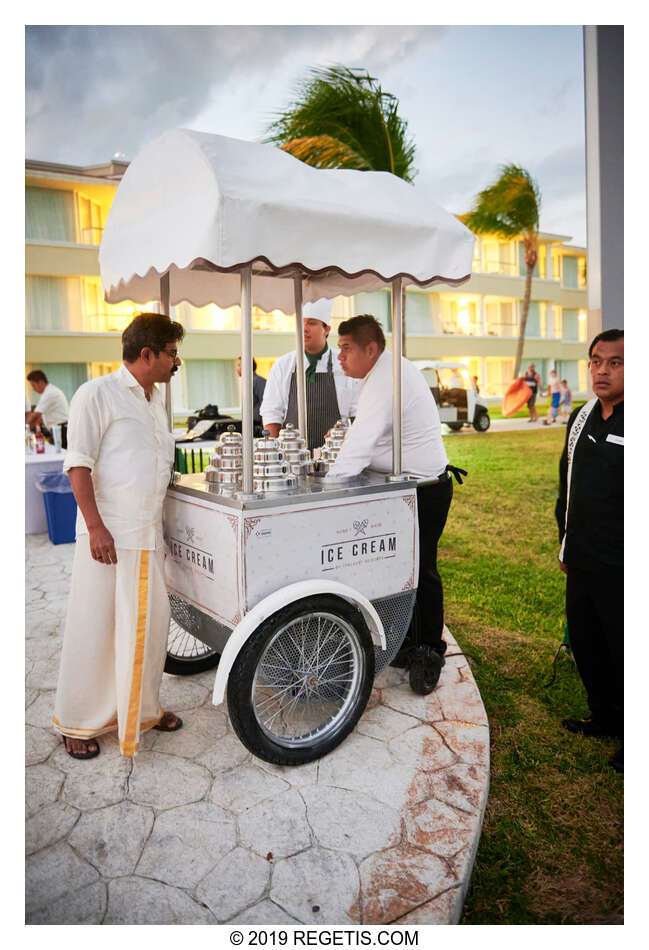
[25,535,489,925]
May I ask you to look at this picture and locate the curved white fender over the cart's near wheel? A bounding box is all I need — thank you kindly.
[212,581,385,706]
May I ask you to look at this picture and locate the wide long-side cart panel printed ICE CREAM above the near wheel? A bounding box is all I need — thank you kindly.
[243,488,419,611]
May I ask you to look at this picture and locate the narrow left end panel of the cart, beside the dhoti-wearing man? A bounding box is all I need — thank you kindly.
[164,491,241,627]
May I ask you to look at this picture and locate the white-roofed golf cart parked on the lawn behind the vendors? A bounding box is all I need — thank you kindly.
[413,360,491,432]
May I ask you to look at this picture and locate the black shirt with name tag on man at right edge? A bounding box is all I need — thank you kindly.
[555,400,624,571]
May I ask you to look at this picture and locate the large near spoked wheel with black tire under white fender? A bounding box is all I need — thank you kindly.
[228,594,374,765]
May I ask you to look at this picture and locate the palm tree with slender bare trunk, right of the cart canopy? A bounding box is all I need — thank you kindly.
[462,165,541,379]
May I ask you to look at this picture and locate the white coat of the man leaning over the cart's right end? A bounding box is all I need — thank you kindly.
[325,350,448,481]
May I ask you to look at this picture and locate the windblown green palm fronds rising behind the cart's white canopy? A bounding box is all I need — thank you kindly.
[264,66,417,356]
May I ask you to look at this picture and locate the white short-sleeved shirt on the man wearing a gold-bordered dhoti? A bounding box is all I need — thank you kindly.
[63,365,175,551]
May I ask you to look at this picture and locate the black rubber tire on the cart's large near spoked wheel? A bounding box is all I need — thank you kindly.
[227,594,374,765]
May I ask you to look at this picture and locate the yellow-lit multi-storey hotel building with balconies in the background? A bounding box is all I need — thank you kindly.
[25,160,587,418]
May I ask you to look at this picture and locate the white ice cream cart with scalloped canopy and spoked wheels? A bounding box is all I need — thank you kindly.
[99,130,474,764]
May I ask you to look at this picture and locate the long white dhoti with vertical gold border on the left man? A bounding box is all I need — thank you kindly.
[52,534,169,756]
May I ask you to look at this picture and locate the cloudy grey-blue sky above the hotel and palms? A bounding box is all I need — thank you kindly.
[26,26,586,244]
